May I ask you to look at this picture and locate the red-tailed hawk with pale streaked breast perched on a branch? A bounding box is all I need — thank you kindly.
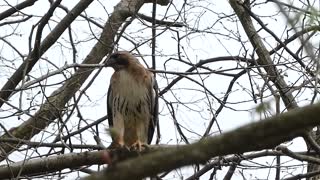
[106,51,158,150]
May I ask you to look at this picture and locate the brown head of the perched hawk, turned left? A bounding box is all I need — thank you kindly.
[106,51,139,71]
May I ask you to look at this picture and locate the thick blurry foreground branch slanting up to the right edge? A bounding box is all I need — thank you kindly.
[86,104,320,180]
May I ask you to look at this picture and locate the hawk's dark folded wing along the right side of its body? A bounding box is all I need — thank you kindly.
[148,75,159,144]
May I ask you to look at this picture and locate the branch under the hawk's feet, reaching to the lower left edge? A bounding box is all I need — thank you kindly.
[0,145,170,179]
